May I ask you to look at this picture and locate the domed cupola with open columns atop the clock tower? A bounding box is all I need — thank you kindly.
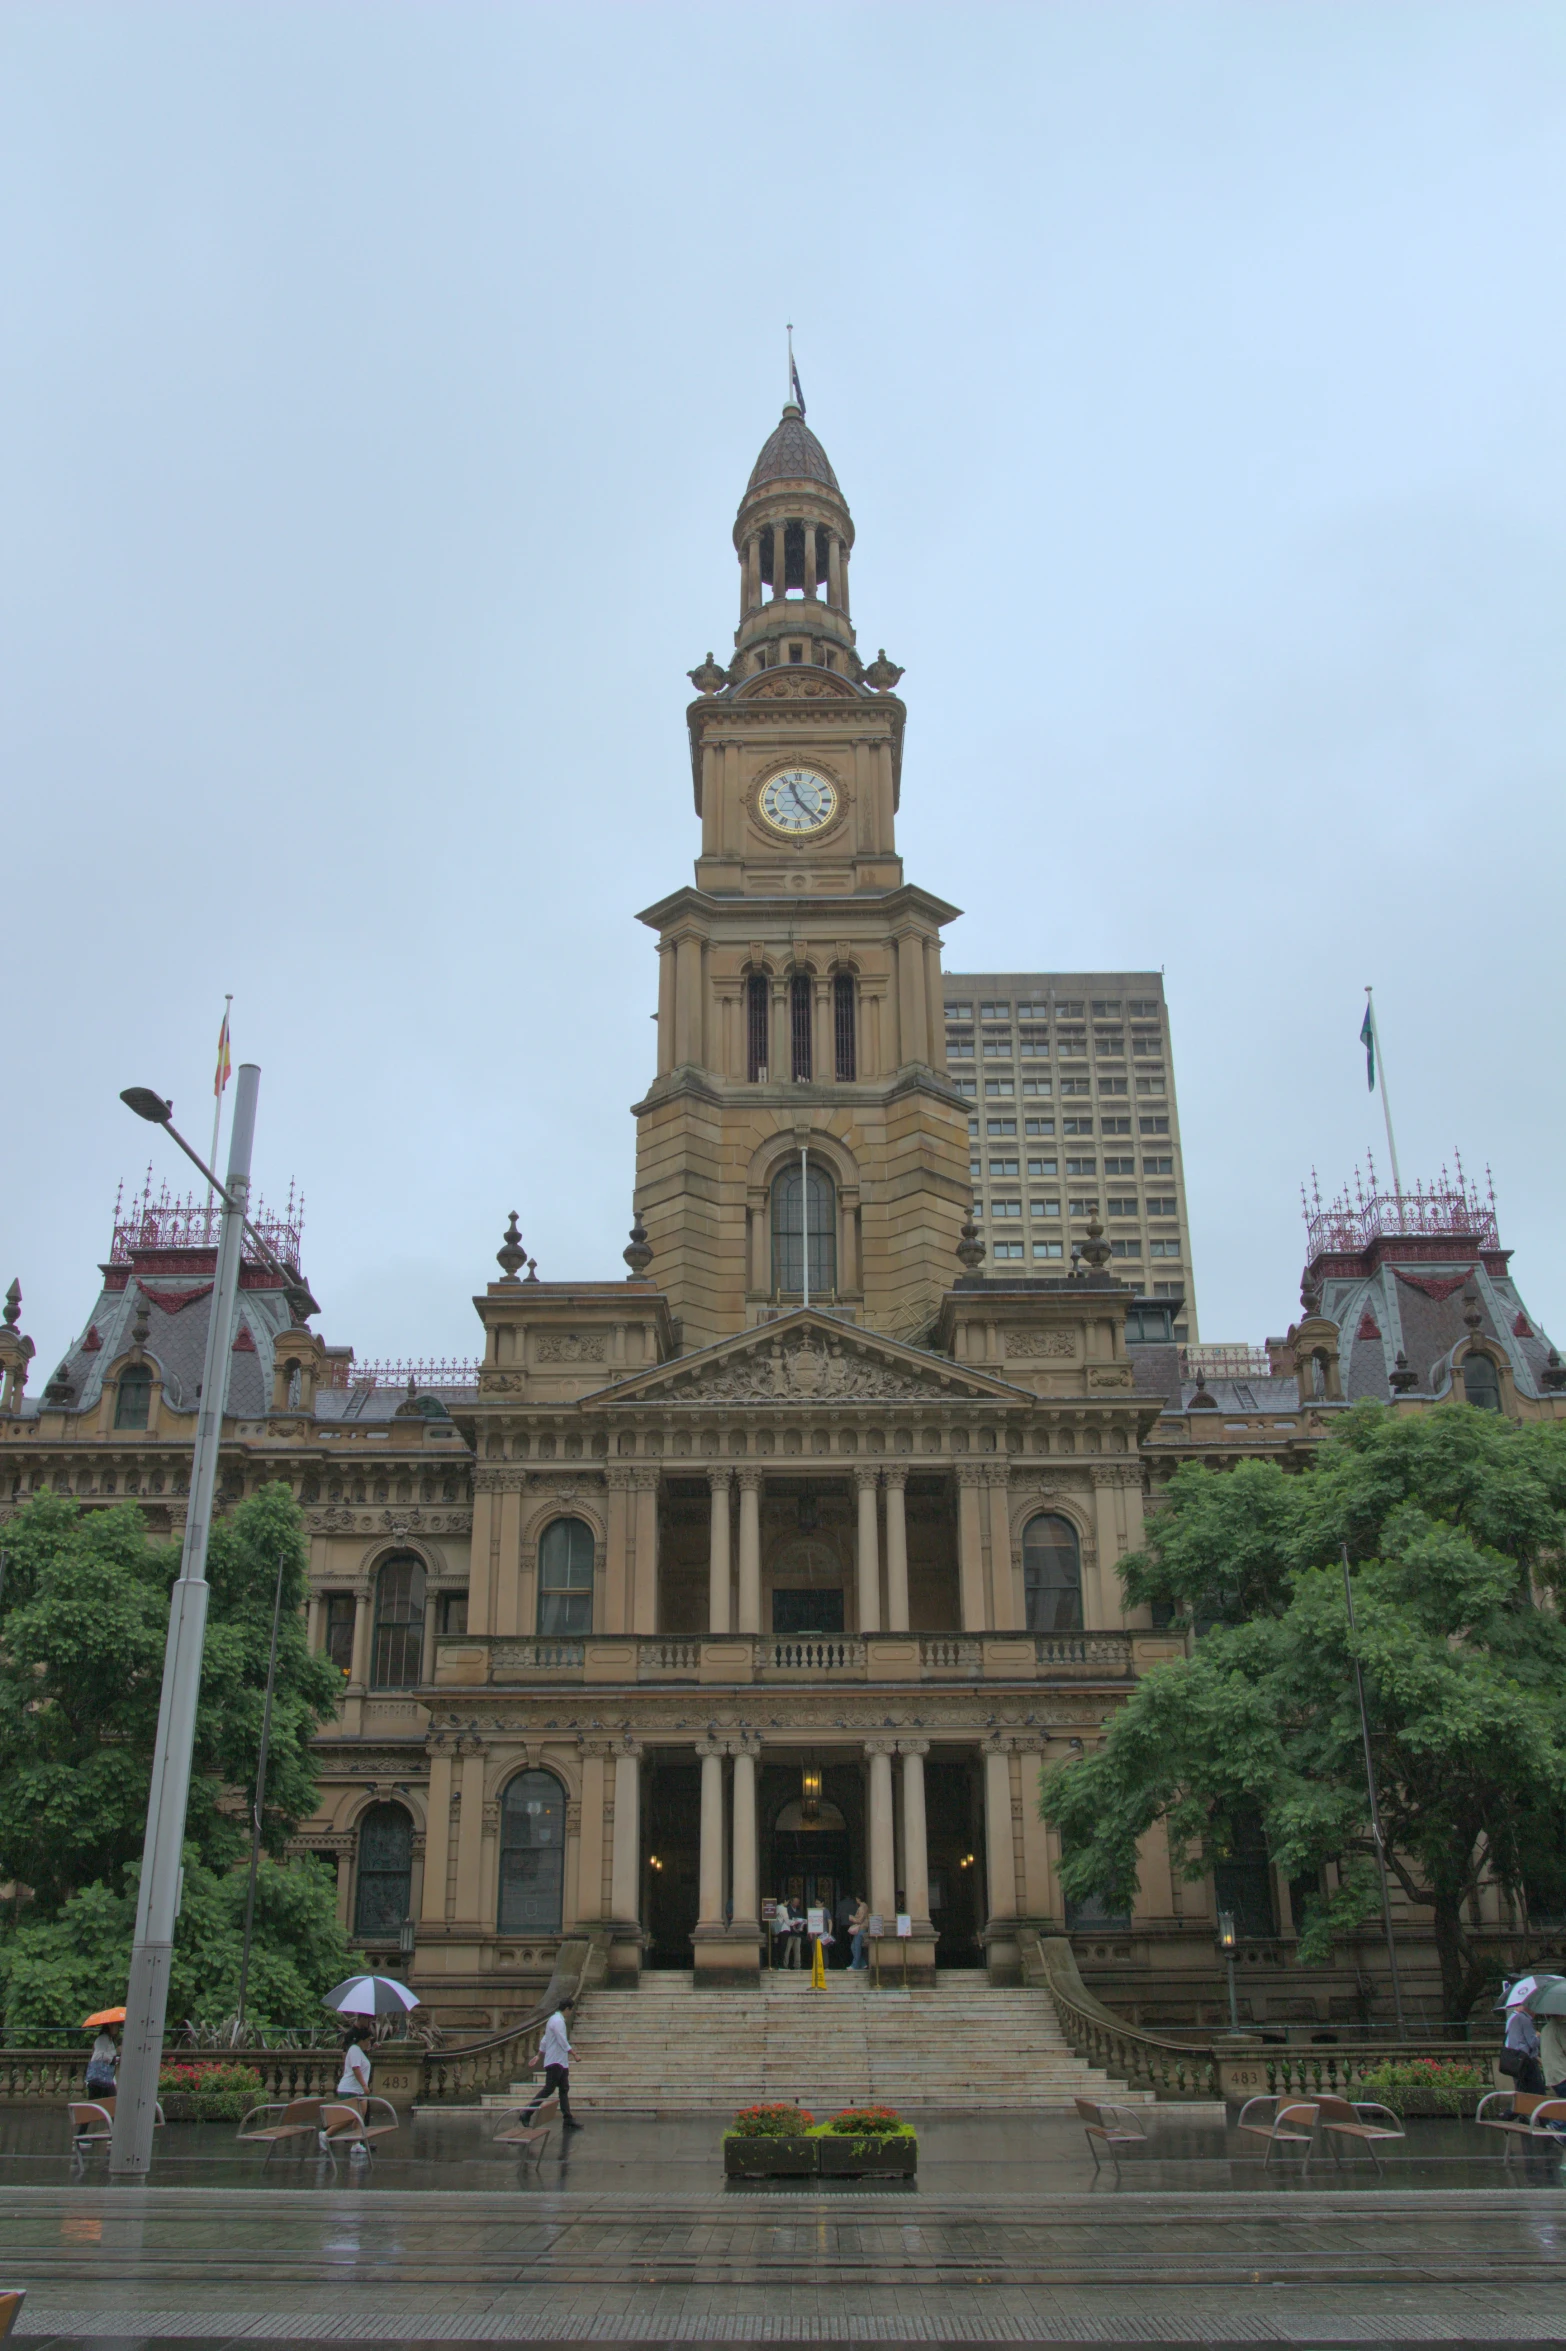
[731,400,863,682]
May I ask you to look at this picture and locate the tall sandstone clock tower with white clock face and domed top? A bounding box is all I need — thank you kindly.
[635,400,971,1349]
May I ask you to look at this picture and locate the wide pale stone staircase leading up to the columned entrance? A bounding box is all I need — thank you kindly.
[536,1970,1150,2118]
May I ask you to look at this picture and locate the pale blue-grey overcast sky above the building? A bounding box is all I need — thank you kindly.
[0,0,1566,1387]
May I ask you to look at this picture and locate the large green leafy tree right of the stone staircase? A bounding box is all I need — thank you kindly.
[1042,1404,1566,2015]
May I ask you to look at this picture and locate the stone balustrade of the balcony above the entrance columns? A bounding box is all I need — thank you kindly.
[435,1632,1136,1688]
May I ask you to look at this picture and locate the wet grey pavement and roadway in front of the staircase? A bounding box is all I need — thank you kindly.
[0,2109,1566,2351]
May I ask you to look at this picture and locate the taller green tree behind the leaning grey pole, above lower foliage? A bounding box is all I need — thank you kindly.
[0,1486,341,1918]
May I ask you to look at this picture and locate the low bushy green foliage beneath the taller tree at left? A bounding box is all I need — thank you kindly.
[0,1846,353,2045]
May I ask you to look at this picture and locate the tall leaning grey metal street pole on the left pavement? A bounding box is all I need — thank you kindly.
[108,1060,261,2177]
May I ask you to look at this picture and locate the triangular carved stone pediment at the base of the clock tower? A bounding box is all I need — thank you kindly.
[581,1307,1037,1408]
